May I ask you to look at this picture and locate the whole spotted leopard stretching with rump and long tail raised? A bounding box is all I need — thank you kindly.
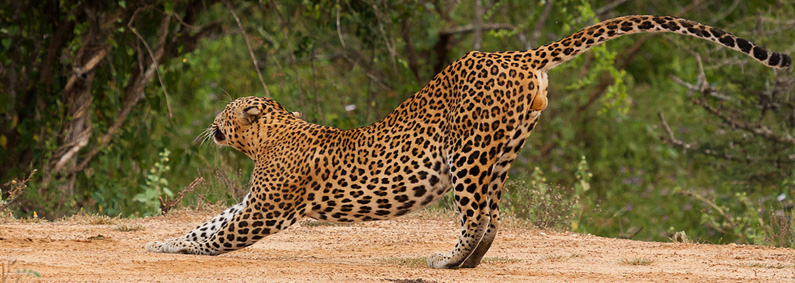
[146,16,792,269]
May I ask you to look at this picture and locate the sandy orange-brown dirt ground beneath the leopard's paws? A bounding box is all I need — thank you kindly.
[0,211,795,282]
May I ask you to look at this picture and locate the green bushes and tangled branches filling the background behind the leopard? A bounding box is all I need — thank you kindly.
[0,0,795,247]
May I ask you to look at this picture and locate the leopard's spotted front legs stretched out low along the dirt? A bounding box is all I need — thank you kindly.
[146,190,303,255]
